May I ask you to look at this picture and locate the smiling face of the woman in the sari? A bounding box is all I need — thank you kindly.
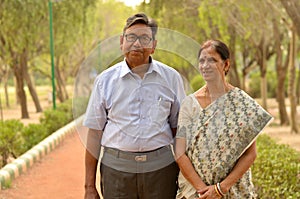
[199,46,229,82]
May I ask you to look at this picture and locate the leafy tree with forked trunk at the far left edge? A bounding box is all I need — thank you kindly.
[0,0,46,118]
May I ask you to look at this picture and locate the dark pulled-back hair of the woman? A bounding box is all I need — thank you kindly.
[198,39,230,60]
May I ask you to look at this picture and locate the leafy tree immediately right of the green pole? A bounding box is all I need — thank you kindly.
[48,0,95,102]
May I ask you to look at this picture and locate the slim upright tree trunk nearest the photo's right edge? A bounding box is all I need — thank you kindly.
[288,27,299,133]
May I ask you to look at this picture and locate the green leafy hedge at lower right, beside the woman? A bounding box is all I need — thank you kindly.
[252,135,300,199]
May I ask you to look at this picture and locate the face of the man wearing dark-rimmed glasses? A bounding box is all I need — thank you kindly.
[120,24,156,68]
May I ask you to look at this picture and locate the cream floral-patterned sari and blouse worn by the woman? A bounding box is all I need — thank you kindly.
[176,88,272,199]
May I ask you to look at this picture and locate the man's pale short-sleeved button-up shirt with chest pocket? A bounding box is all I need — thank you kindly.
[83,60,185,151]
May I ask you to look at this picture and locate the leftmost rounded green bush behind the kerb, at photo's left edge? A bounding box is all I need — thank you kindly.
[0,119,23,166]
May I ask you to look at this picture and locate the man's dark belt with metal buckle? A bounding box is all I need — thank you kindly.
[104,146,171,162]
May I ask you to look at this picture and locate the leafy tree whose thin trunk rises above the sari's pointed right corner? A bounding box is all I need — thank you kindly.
[230,0,274,109]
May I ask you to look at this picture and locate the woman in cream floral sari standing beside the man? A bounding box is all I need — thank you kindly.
[175,40,272,199]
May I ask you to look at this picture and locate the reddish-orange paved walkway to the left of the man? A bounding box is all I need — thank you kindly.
[0,128,85,199]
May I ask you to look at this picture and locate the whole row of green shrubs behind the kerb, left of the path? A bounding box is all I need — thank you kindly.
[0,100,73,168]
